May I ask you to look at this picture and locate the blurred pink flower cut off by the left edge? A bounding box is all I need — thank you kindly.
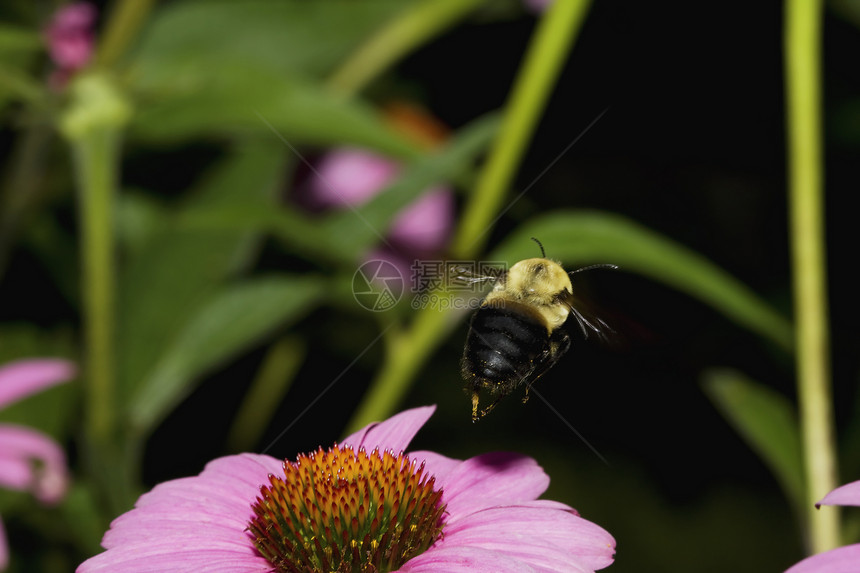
[0,358,75,570]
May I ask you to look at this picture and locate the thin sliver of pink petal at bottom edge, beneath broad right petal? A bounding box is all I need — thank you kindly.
[397,546,537,573]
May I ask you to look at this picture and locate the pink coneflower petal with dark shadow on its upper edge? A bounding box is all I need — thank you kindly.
[436,452,549,516]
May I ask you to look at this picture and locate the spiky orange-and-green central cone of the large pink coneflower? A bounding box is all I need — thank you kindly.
[248,446,445,573]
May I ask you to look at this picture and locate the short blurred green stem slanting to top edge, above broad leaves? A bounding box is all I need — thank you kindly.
[328,0,485,95]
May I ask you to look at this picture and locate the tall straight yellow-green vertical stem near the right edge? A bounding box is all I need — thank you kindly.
[784,0,839,553]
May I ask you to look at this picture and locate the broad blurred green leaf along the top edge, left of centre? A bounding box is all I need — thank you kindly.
[130,0,409,86]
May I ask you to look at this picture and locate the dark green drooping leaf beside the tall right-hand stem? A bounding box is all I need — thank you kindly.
[703,370,806,515]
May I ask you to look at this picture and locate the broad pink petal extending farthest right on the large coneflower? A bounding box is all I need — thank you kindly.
[442,500,615,571]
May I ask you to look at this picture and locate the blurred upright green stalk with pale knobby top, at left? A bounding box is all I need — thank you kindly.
[60,71,129,514]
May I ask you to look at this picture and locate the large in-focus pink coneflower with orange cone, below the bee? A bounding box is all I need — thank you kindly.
[78,406,615,573]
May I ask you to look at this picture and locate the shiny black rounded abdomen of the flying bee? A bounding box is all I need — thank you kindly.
[462,306,549,387]
